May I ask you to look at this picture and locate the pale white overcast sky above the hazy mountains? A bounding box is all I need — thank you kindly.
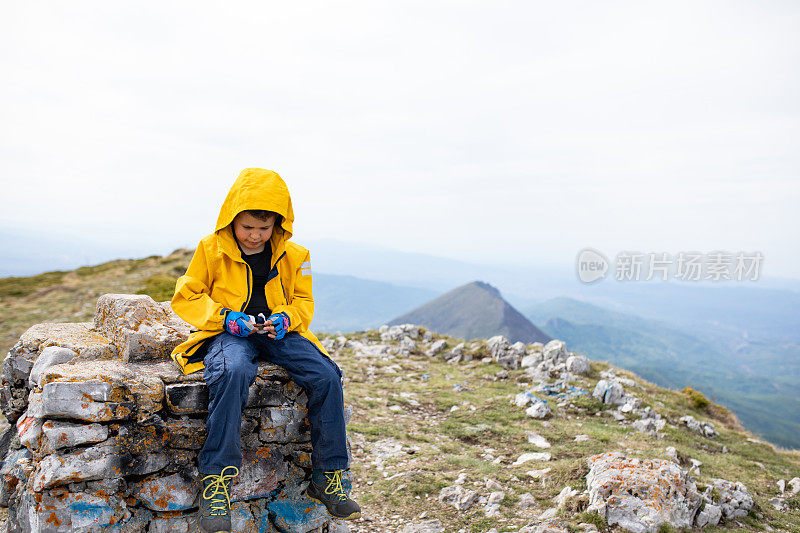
[0,0,800,278]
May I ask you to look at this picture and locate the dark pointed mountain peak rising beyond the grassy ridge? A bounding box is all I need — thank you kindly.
[389,281,550,344]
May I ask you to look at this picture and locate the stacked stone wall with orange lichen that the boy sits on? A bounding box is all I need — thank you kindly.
[0,295,351,533]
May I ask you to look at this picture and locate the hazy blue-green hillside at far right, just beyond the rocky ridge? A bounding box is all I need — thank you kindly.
[527,298,800,448]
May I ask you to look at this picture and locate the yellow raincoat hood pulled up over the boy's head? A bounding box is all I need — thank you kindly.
[214,168,294,257]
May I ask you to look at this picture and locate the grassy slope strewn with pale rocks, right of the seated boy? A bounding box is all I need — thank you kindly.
[326,331,800,532]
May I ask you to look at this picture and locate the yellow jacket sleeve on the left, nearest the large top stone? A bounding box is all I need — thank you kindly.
[171,242,230,331]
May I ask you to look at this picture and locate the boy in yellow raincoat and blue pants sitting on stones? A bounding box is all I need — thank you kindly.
[172,168,361,533]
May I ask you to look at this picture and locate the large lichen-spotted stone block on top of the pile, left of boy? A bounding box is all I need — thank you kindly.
[94,294,189,362]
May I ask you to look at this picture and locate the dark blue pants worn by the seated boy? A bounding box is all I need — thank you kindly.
[199,332,348,474]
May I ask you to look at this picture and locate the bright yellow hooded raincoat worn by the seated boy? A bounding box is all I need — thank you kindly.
[172,168,330,374]
